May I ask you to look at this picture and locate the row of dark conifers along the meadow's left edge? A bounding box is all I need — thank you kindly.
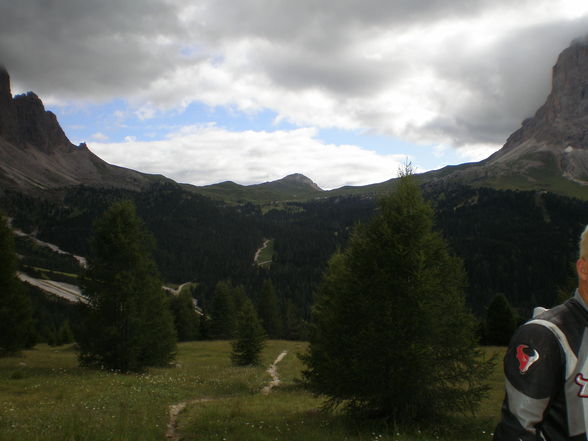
[0,201,277,372]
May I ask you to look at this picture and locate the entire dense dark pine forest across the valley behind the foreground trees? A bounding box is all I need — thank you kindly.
[0,180,588,330]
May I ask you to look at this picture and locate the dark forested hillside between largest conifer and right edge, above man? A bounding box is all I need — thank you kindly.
[430,187,588,317]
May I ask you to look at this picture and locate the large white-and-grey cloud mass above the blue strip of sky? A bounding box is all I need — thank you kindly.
[117,0,588,150]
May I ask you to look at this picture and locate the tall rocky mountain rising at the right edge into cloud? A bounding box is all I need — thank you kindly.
[431,38,588,189]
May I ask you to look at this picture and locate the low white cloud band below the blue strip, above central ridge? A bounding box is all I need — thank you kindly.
[89,125,406,189]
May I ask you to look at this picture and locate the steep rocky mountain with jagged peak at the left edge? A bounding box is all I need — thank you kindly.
[0,67,165,192]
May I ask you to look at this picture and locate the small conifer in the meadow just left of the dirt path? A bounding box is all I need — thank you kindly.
[231,298,265,366]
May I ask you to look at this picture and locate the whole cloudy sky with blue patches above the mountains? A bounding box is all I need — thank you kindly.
[0,0,588,189]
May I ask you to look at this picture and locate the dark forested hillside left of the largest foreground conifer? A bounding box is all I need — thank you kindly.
[0,180,373,318]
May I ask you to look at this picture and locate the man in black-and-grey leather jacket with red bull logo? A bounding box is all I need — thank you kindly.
[494,226,588,441]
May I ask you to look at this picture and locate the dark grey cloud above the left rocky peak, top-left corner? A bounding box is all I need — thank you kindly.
[0,0,191,99]
